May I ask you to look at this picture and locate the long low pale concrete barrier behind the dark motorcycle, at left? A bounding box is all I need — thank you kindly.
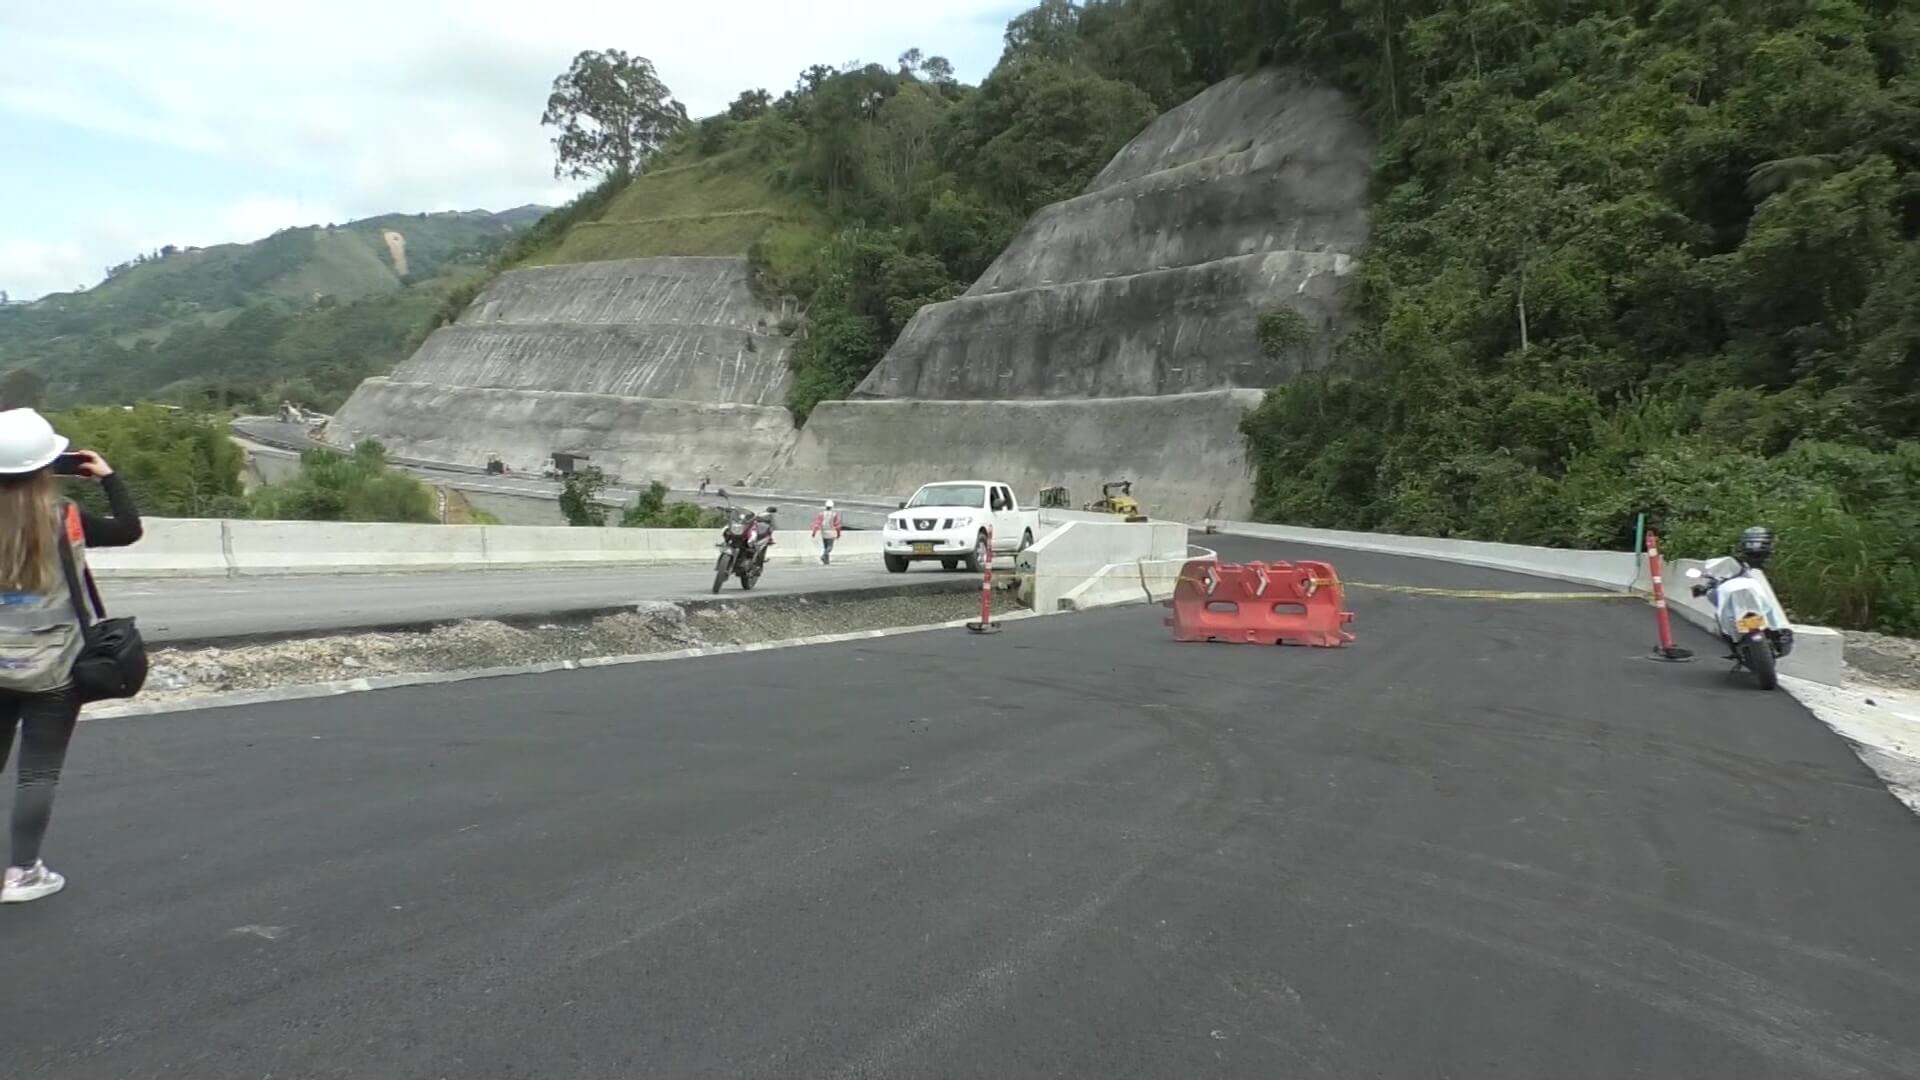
[88,517,881,578]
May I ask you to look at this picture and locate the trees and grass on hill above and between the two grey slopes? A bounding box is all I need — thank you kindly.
[499,35,1144,423]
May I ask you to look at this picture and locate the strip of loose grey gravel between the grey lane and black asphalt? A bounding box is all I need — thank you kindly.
[138,592,979,701]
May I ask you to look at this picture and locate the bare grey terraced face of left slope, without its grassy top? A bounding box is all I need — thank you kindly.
[328,258,793,482]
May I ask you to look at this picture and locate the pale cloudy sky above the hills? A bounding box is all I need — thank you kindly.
[0,0,1029,300]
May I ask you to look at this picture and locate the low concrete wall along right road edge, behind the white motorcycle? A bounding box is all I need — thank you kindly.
[1206,521,1847,686]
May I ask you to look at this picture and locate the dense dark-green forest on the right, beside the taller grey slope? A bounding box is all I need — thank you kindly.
[1190,0,1920,632]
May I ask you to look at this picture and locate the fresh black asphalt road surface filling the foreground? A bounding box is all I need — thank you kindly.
[0,538,1920,1080]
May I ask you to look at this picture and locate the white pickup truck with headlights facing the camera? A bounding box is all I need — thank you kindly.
[881,480,1041,575]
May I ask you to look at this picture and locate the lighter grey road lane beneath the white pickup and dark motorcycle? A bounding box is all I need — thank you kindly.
[102,555,967,644]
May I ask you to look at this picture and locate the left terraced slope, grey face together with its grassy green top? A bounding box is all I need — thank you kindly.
[328,158,820,482]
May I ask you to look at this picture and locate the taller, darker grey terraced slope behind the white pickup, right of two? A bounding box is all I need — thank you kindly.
[776,71,1373,517]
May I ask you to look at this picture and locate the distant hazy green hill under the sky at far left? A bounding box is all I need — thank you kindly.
[0,208,543,405]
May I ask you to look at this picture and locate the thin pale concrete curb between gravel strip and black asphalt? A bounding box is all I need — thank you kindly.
[81,611,1039,721]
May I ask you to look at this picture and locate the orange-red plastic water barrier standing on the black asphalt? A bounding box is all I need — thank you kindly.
[1167,559,1354,648]
